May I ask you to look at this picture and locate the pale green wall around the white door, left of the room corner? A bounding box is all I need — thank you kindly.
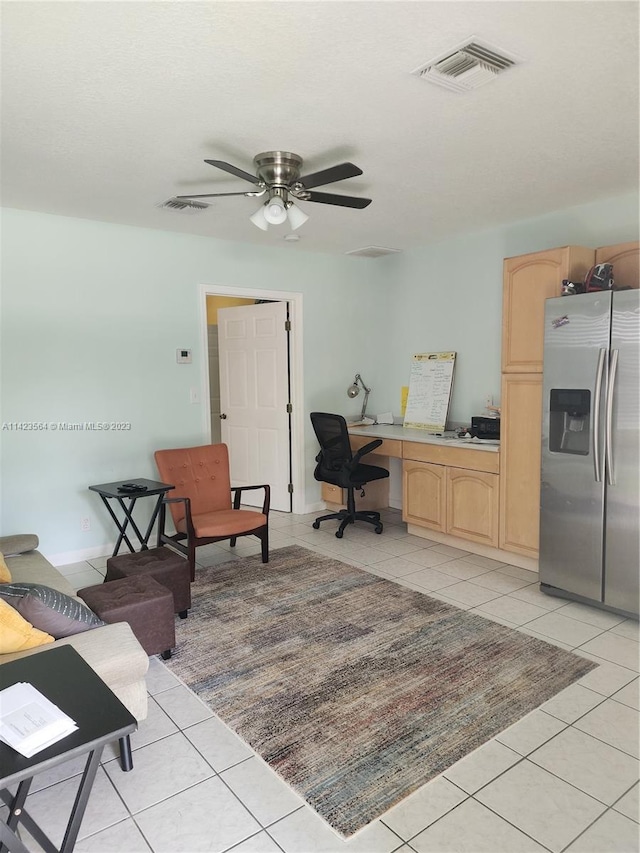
[0,210,384,555]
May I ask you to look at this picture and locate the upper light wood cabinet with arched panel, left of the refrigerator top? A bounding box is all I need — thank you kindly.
[502,246,595,373]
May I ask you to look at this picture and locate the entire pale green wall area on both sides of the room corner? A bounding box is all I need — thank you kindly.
[0,193,638,555]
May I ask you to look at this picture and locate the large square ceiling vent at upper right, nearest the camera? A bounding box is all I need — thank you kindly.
[411,36,520,92]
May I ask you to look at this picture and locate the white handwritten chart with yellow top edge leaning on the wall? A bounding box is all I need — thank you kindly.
[404,352,456,432]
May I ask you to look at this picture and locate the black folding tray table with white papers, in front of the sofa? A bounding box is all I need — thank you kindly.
[0,646,137,853]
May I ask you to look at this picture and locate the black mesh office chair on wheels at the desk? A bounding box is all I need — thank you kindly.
[311,412,389,539]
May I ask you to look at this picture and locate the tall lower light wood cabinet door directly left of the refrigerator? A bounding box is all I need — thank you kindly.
[499,372,544,559]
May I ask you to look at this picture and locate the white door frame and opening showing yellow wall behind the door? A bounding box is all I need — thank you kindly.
[201,285,305,513]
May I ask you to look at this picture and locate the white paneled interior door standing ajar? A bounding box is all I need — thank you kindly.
[218,302,291,512]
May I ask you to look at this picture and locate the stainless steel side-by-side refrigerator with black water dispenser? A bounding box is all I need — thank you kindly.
[540,290,640,616]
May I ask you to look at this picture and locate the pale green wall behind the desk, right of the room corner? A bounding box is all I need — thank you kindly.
[371,193,638,423]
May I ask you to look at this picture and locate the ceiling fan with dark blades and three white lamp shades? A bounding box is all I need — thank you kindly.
[176,151,371,231]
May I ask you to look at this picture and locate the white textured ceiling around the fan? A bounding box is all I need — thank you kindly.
[1,0,639,253]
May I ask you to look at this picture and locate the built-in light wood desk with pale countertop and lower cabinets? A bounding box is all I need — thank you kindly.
[340,424,537,569]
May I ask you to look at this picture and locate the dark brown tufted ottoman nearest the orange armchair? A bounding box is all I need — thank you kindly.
[105,548,191,619]
